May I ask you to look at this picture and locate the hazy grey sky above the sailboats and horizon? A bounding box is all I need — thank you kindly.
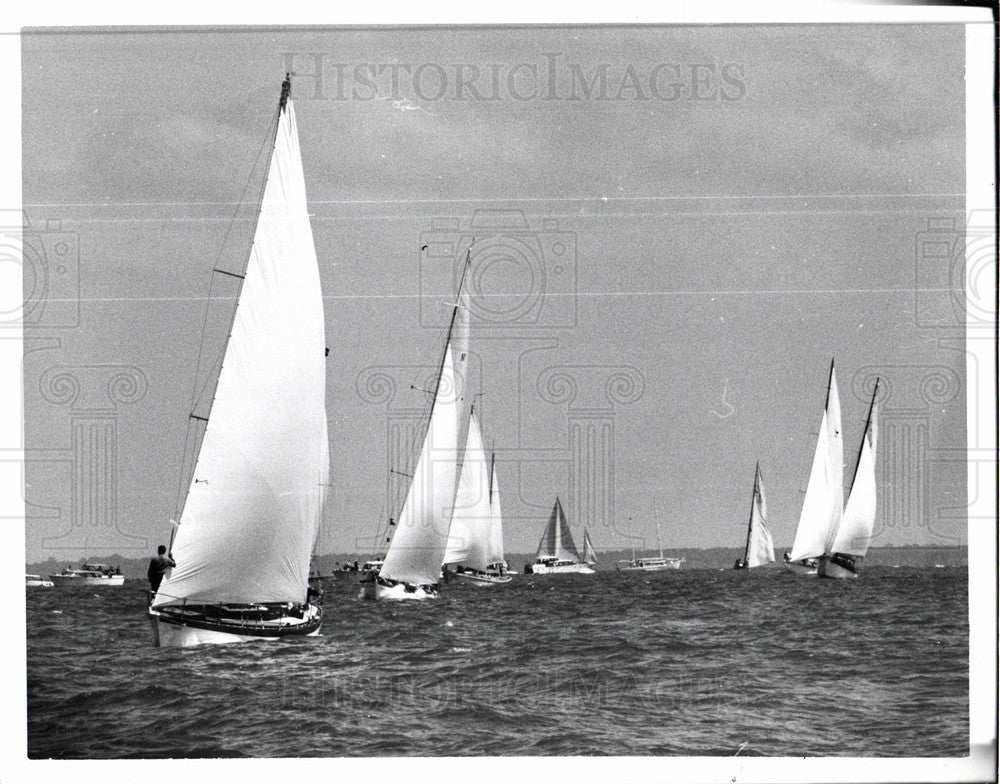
[22,25,967,561]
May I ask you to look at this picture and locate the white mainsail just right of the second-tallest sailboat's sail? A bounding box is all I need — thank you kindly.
[444,412,494,571]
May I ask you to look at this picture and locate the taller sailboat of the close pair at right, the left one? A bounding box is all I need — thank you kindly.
[784,361,844,575]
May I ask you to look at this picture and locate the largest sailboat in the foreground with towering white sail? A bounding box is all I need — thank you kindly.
[148,76,330,646]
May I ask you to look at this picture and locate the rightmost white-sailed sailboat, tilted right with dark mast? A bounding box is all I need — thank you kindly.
[819,379,878,578]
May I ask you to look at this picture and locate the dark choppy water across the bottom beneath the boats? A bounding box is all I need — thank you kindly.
[27,567,968,758]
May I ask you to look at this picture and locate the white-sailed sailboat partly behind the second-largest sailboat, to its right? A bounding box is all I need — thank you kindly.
[444,405,511,585]
